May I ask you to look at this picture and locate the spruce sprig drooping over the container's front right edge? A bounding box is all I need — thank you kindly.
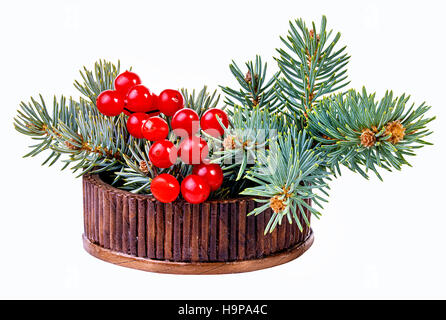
[242,130,329,233]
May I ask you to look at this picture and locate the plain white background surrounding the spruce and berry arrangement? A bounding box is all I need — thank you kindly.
[0,0,446,299]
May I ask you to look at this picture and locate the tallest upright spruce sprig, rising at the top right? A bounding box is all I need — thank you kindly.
[276,16,350,114]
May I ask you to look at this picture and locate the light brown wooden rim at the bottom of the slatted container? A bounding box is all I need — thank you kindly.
[83,231,314,274]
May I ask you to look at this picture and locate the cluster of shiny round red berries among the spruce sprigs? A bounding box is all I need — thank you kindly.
[96,71,229,203]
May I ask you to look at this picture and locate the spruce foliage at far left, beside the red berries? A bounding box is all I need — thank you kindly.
[14,61,135,176]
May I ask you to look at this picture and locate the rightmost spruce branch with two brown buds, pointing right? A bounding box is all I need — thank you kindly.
[307,89,435,179]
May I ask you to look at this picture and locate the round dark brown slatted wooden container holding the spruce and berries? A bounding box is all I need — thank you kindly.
[83,174,313,274]
